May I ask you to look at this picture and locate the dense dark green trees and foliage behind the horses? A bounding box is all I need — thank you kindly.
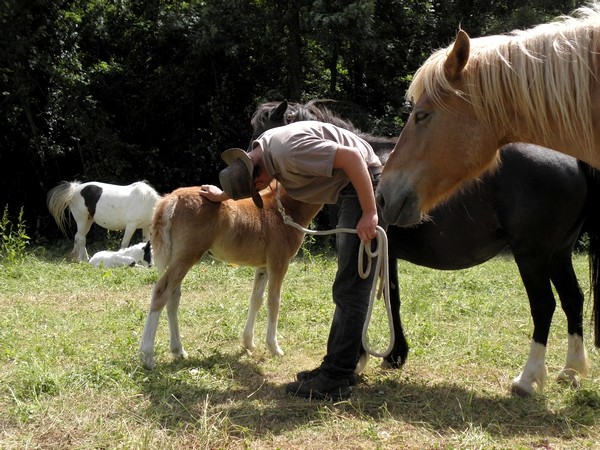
[0,0,582,239]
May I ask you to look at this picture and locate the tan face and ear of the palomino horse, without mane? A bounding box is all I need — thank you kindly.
[377,32,497,225]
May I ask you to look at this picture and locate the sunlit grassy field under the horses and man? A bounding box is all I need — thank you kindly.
[0,249,600,449]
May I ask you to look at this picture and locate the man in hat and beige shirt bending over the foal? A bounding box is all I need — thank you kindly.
[200,121,385,400]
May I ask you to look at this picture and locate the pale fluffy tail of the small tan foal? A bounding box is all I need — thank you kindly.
[150,195,177,273]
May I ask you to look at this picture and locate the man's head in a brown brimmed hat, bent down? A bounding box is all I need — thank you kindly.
[219,148,265,208]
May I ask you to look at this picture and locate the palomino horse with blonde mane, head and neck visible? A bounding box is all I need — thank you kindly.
[377,4,600,225]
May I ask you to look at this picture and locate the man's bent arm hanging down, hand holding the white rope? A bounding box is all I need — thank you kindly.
[333,146,379,241]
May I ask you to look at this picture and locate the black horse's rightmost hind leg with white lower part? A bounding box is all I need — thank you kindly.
[550,249,590,386]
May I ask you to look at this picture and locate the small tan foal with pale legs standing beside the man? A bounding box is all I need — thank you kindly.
[140,183,322,369]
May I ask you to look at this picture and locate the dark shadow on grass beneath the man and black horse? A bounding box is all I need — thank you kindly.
[129,353,600,437]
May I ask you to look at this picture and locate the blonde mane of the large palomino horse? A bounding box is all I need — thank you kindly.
[406,3,600,160]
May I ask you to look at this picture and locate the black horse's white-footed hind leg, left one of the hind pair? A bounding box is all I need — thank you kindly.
[512,254,556,395]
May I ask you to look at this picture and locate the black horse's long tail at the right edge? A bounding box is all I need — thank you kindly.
[581,163,600,348]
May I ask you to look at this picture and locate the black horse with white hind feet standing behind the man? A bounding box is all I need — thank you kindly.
[251,100,600,395]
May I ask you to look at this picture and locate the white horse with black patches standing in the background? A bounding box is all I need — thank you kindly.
[46,181,160,261]
